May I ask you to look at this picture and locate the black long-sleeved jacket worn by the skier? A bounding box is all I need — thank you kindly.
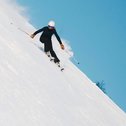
[34,26,62,44]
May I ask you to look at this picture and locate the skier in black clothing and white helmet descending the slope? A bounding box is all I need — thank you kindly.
[31,21,64,63]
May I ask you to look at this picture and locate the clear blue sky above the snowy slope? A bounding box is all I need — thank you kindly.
[17,0,126,112]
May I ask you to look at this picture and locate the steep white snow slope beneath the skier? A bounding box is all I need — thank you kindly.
[0,0,126,126]
